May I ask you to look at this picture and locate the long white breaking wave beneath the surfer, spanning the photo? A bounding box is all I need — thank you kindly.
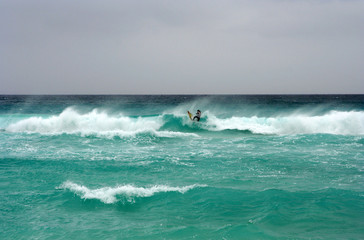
[5,108,364,137]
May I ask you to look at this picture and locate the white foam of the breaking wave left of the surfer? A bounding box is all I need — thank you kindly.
[6,108,163,137]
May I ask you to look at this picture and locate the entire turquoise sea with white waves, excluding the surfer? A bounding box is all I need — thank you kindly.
[0,95,364,239]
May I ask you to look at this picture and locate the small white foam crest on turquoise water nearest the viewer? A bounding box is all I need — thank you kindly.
[58,181,206,204]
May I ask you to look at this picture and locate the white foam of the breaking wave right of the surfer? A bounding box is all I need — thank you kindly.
[206,111,364,135]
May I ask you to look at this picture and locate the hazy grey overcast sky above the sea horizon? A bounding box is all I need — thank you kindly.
[0,0,364,94]
